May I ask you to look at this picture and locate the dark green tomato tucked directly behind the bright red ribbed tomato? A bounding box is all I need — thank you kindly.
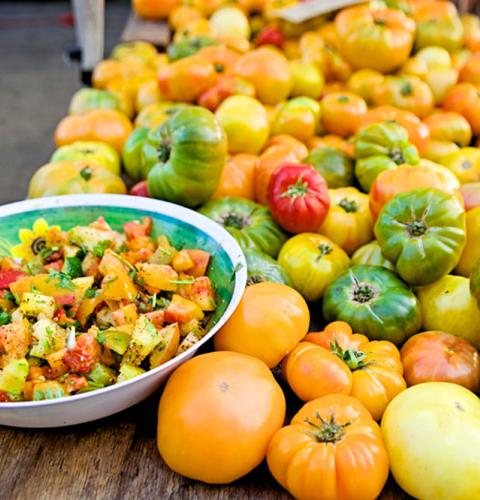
[303,147,355,189]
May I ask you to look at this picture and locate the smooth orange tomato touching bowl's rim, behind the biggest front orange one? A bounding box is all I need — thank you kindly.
[214,282,310,368]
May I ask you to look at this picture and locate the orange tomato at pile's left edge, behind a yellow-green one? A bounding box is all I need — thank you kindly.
[55,109,133,153]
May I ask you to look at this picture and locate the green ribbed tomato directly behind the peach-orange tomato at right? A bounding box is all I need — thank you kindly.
[355,122,420,193]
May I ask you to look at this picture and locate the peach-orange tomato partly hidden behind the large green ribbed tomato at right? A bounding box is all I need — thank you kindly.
[369,163,463,219]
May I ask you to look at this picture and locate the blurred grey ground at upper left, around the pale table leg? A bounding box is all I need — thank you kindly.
[0,0,130,204]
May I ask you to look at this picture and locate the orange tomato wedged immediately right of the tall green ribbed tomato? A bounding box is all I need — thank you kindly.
[212,153,258,200]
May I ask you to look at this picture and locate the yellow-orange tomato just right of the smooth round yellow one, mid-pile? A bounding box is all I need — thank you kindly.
[272,97,320,142]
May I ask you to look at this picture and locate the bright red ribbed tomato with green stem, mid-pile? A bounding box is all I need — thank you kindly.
[268,163,330,233]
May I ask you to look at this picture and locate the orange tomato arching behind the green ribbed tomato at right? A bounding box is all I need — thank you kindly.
[360,106,430,153]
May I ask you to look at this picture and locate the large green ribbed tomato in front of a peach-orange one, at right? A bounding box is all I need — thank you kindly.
[375,189,466,285]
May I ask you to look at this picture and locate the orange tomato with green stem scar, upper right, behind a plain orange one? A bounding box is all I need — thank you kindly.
[372,75,434,118]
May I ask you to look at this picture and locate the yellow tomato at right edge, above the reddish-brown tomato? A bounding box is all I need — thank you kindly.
[418,274,480,349]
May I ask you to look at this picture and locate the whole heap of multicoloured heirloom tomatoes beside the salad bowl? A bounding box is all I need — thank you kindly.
[29,0,480,499]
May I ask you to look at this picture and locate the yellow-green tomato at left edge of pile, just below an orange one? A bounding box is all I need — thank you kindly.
[50,141,120,175]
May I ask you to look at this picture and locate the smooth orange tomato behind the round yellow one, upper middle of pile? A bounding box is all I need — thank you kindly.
[235,47,292,104]
